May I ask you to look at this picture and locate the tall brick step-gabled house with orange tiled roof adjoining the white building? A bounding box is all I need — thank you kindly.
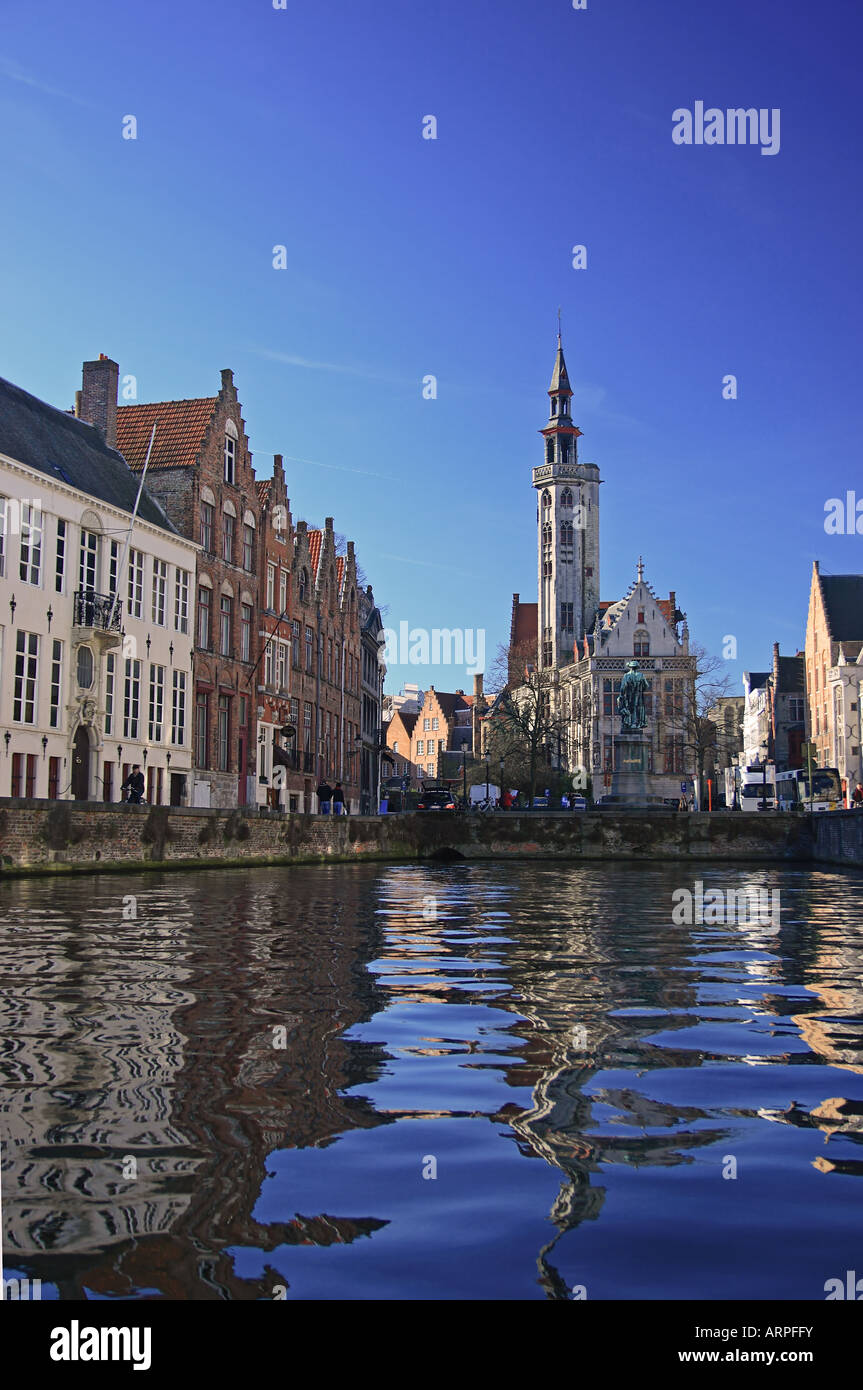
[114,370,260,806]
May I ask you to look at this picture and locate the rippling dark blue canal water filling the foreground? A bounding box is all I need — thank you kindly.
[0,863,863,1300]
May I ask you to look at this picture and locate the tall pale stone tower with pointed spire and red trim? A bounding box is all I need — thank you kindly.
[534,334,600,666]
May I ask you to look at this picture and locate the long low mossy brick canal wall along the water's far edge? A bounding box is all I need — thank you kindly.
[0,798,822,876]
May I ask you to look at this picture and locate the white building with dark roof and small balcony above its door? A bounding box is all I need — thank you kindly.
[0,378,197,805]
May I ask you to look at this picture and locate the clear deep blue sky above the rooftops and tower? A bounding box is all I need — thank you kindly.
[0,0,863,689]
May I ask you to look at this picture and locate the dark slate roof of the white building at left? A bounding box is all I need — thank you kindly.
[0,377,176,535]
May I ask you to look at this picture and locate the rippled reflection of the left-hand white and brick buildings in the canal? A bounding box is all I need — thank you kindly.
[1,866,385,1300]
